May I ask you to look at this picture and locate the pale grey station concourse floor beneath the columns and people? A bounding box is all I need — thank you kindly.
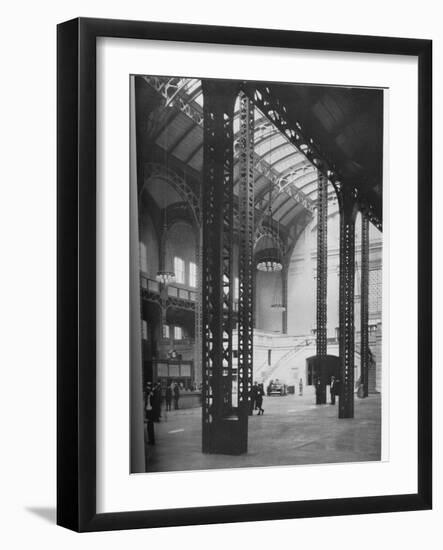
[146,386,381,472]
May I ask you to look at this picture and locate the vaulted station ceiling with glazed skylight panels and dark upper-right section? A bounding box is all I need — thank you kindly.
[139,76,383,252]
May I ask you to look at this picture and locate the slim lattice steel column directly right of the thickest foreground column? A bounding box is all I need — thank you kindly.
[238,92,254,437]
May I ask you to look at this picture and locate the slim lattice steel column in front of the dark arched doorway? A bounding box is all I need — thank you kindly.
[317,172,328,404]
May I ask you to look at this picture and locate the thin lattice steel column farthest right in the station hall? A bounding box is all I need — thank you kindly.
[360,213,369,397]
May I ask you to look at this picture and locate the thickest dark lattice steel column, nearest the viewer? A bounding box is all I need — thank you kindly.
[202,80,241,453]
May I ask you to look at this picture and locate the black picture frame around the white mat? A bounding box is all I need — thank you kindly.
[57,18,432,531]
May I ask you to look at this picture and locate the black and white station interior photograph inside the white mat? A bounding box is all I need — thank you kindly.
[128,74,389,475]
